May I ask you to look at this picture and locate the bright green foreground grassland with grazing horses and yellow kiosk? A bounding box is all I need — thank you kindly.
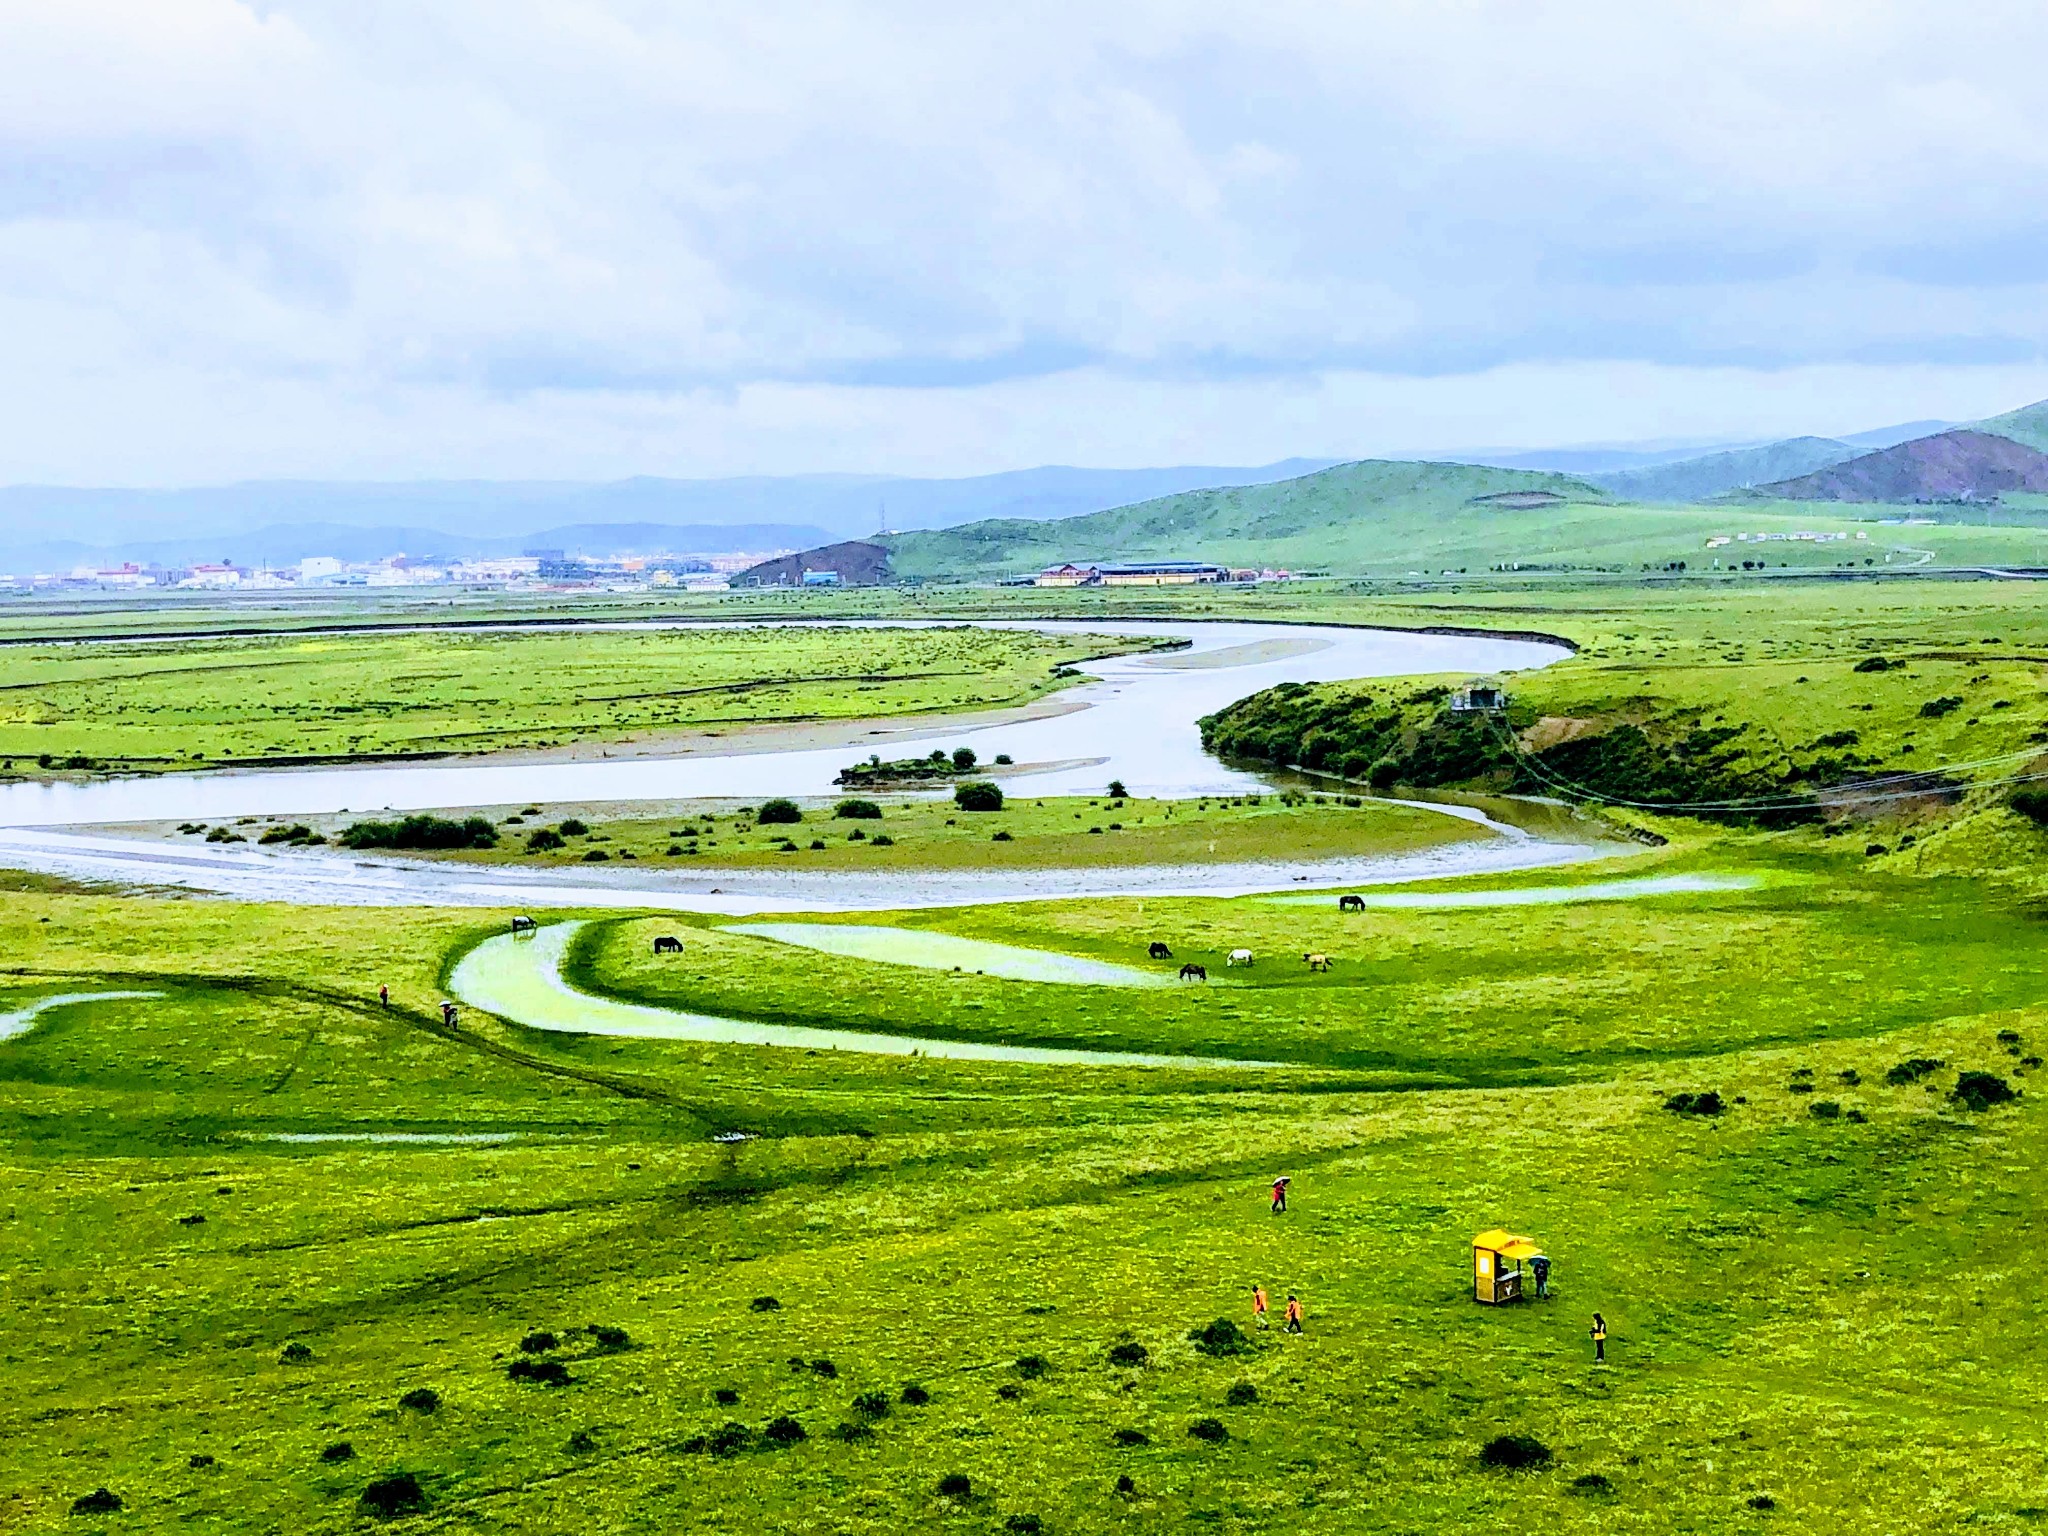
[0,844,2048,1532]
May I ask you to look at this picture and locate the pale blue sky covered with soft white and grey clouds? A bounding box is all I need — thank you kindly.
[0,0,2048,485]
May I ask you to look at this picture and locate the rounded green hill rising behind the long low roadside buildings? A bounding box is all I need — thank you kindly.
[889,459,1608,580]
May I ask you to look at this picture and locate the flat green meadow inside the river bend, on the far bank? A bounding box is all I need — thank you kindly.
[0,625,1151,774]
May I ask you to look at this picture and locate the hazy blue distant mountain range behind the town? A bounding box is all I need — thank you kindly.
[0,459,1331,571]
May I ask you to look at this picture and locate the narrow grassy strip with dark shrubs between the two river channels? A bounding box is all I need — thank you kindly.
[315,798,1485,870]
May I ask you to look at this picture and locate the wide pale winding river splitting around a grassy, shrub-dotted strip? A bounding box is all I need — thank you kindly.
[0,621,1614,913]
